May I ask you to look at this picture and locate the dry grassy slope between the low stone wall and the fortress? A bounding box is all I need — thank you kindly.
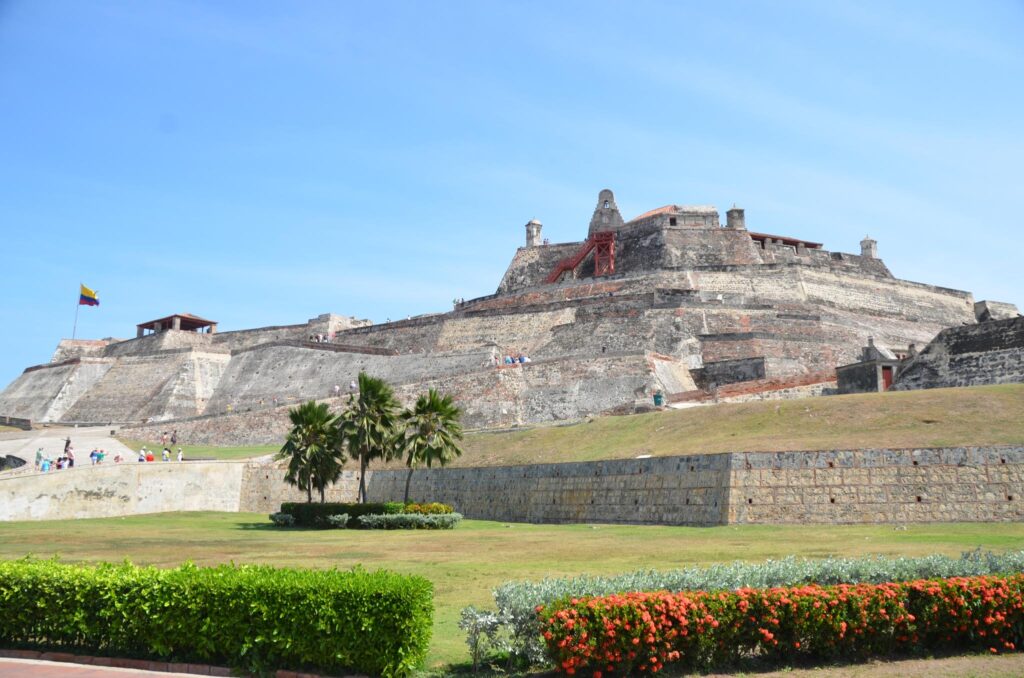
[458,384,1024,466]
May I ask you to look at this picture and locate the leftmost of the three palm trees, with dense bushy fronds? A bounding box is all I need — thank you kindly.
[278,400,345,504]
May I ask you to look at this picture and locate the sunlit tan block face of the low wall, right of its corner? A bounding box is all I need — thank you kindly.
[728,448,1024,524]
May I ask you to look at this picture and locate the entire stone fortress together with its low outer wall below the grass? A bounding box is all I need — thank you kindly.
[0,190,1024,525]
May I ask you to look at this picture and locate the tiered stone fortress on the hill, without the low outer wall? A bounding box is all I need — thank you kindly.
[0,190,1016,443]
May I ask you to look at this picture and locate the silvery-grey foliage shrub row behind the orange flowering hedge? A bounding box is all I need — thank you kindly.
[463,549,1024,665]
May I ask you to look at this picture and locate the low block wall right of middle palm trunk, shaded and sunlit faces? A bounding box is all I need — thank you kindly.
[369,448,1024,526]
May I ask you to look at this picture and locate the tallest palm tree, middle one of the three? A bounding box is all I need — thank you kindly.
[341,372,399,504]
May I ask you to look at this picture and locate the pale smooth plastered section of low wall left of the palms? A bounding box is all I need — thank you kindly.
[0,462,245,520]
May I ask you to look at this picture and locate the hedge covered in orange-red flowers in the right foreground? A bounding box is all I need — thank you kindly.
[538,575,1024,677]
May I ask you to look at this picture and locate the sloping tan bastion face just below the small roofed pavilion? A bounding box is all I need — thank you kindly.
[60,351,193,423]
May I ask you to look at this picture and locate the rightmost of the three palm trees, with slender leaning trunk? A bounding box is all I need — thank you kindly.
[401,388,462,504]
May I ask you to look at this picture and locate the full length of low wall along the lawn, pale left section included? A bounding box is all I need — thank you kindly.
[6,447,1024,526]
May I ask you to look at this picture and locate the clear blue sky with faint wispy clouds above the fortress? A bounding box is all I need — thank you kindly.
[0,0,1024,391]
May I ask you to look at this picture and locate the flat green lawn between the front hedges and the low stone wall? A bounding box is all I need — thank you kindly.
[0,513,1024,667]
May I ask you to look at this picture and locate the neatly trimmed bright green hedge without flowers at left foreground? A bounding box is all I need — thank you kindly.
[0,559,433,676]
